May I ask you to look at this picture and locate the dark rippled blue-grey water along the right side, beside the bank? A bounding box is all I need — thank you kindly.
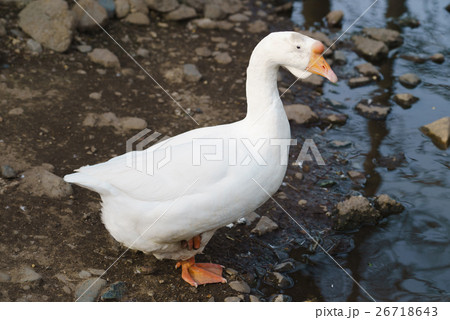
[292,0,450,301]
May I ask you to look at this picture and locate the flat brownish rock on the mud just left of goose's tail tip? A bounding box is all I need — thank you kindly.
[19,166,73,199]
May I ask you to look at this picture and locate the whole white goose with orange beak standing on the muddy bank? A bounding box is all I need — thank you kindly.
[64,32,337,286]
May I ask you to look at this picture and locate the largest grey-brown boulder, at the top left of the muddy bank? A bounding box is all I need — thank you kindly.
[19,0,75,52]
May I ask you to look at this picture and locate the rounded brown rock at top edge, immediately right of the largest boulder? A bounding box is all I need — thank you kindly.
[72,0,108,31]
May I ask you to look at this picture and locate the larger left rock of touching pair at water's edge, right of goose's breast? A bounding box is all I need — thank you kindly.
[334,196,381,230]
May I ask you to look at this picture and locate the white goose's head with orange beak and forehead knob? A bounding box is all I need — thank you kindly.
[260,31,337,83]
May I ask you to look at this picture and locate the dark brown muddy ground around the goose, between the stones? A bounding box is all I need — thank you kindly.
[0,4,366,301]
